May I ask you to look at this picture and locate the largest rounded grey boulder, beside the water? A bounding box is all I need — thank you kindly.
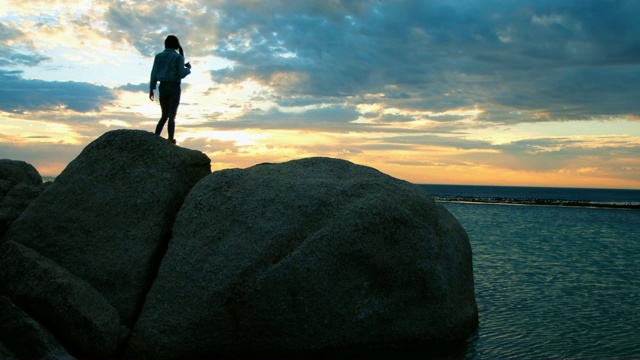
[125,158,478,358]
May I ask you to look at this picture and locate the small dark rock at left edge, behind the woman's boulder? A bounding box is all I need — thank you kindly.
[0,159,45,237]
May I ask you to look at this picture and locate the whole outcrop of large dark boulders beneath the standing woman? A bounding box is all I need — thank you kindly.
[0,130,478,358]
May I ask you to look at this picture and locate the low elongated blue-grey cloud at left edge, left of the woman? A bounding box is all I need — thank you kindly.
[0,69,115,112]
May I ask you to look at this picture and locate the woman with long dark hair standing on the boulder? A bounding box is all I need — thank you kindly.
[149,35,191,144]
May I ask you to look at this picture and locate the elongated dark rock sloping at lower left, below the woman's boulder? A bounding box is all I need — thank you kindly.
[0,240,124,356]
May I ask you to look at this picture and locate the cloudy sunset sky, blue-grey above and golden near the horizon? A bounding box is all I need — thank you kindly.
[0,0,640,189]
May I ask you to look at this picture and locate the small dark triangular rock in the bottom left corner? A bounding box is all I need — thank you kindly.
[0,296,73,359]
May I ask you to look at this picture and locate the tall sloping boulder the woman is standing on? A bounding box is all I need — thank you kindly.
[3,130,211,327]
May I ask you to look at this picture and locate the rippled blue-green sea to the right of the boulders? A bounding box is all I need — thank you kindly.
[420,185,640,359]
